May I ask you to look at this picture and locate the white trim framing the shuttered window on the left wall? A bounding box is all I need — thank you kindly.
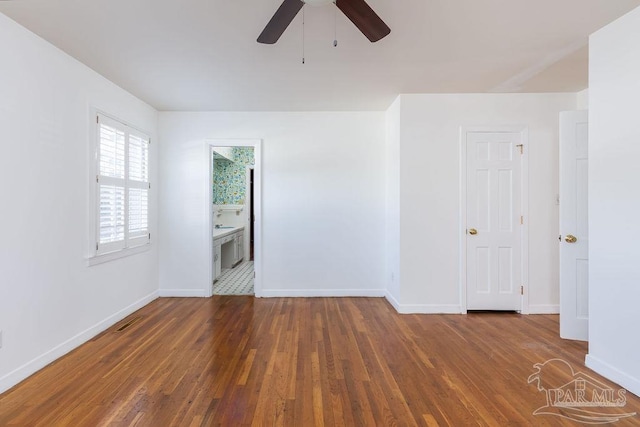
[85,109,154,266]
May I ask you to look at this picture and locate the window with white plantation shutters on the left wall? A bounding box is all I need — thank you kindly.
[96,114,151,255]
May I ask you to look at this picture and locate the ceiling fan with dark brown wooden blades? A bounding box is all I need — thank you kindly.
[258,0,391,44]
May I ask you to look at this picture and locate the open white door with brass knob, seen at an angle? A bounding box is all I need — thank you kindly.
[560,111,589,341]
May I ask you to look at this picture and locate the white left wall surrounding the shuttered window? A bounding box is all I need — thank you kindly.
[0,14,158,392]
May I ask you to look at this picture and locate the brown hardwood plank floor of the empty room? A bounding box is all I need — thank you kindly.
[0,296,640,427]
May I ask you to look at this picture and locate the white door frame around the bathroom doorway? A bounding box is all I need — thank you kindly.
[204,139,262,297]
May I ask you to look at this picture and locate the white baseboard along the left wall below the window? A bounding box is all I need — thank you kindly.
[0,291,158,393]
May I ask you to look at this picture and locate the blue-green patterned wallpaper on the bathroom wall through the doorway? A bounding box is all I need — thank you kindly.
[213,147,254,205]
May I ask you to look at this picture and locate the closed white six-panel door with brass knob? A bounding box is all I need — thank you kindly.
[465,131,523,311]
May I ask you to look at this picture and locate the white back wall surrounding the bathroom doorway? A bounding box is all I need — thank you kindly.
[159,112,385,296]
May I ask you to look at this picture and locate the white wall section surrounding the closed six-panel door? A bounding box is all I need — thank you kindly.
[390,94,576,313]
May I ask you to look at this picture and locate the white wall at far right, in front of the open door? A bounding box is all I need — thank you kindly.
[587,8,640,395]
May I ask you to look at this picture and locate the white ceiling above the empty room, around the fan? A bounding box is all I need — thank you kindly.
[0,0,640,111]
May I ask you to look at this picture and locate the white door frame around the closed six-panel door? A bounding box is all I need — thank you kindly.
[458,125,529,314]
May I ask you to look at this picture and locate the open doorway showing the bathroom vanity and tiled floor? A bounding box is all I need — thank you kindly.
[208,140,260,295]
